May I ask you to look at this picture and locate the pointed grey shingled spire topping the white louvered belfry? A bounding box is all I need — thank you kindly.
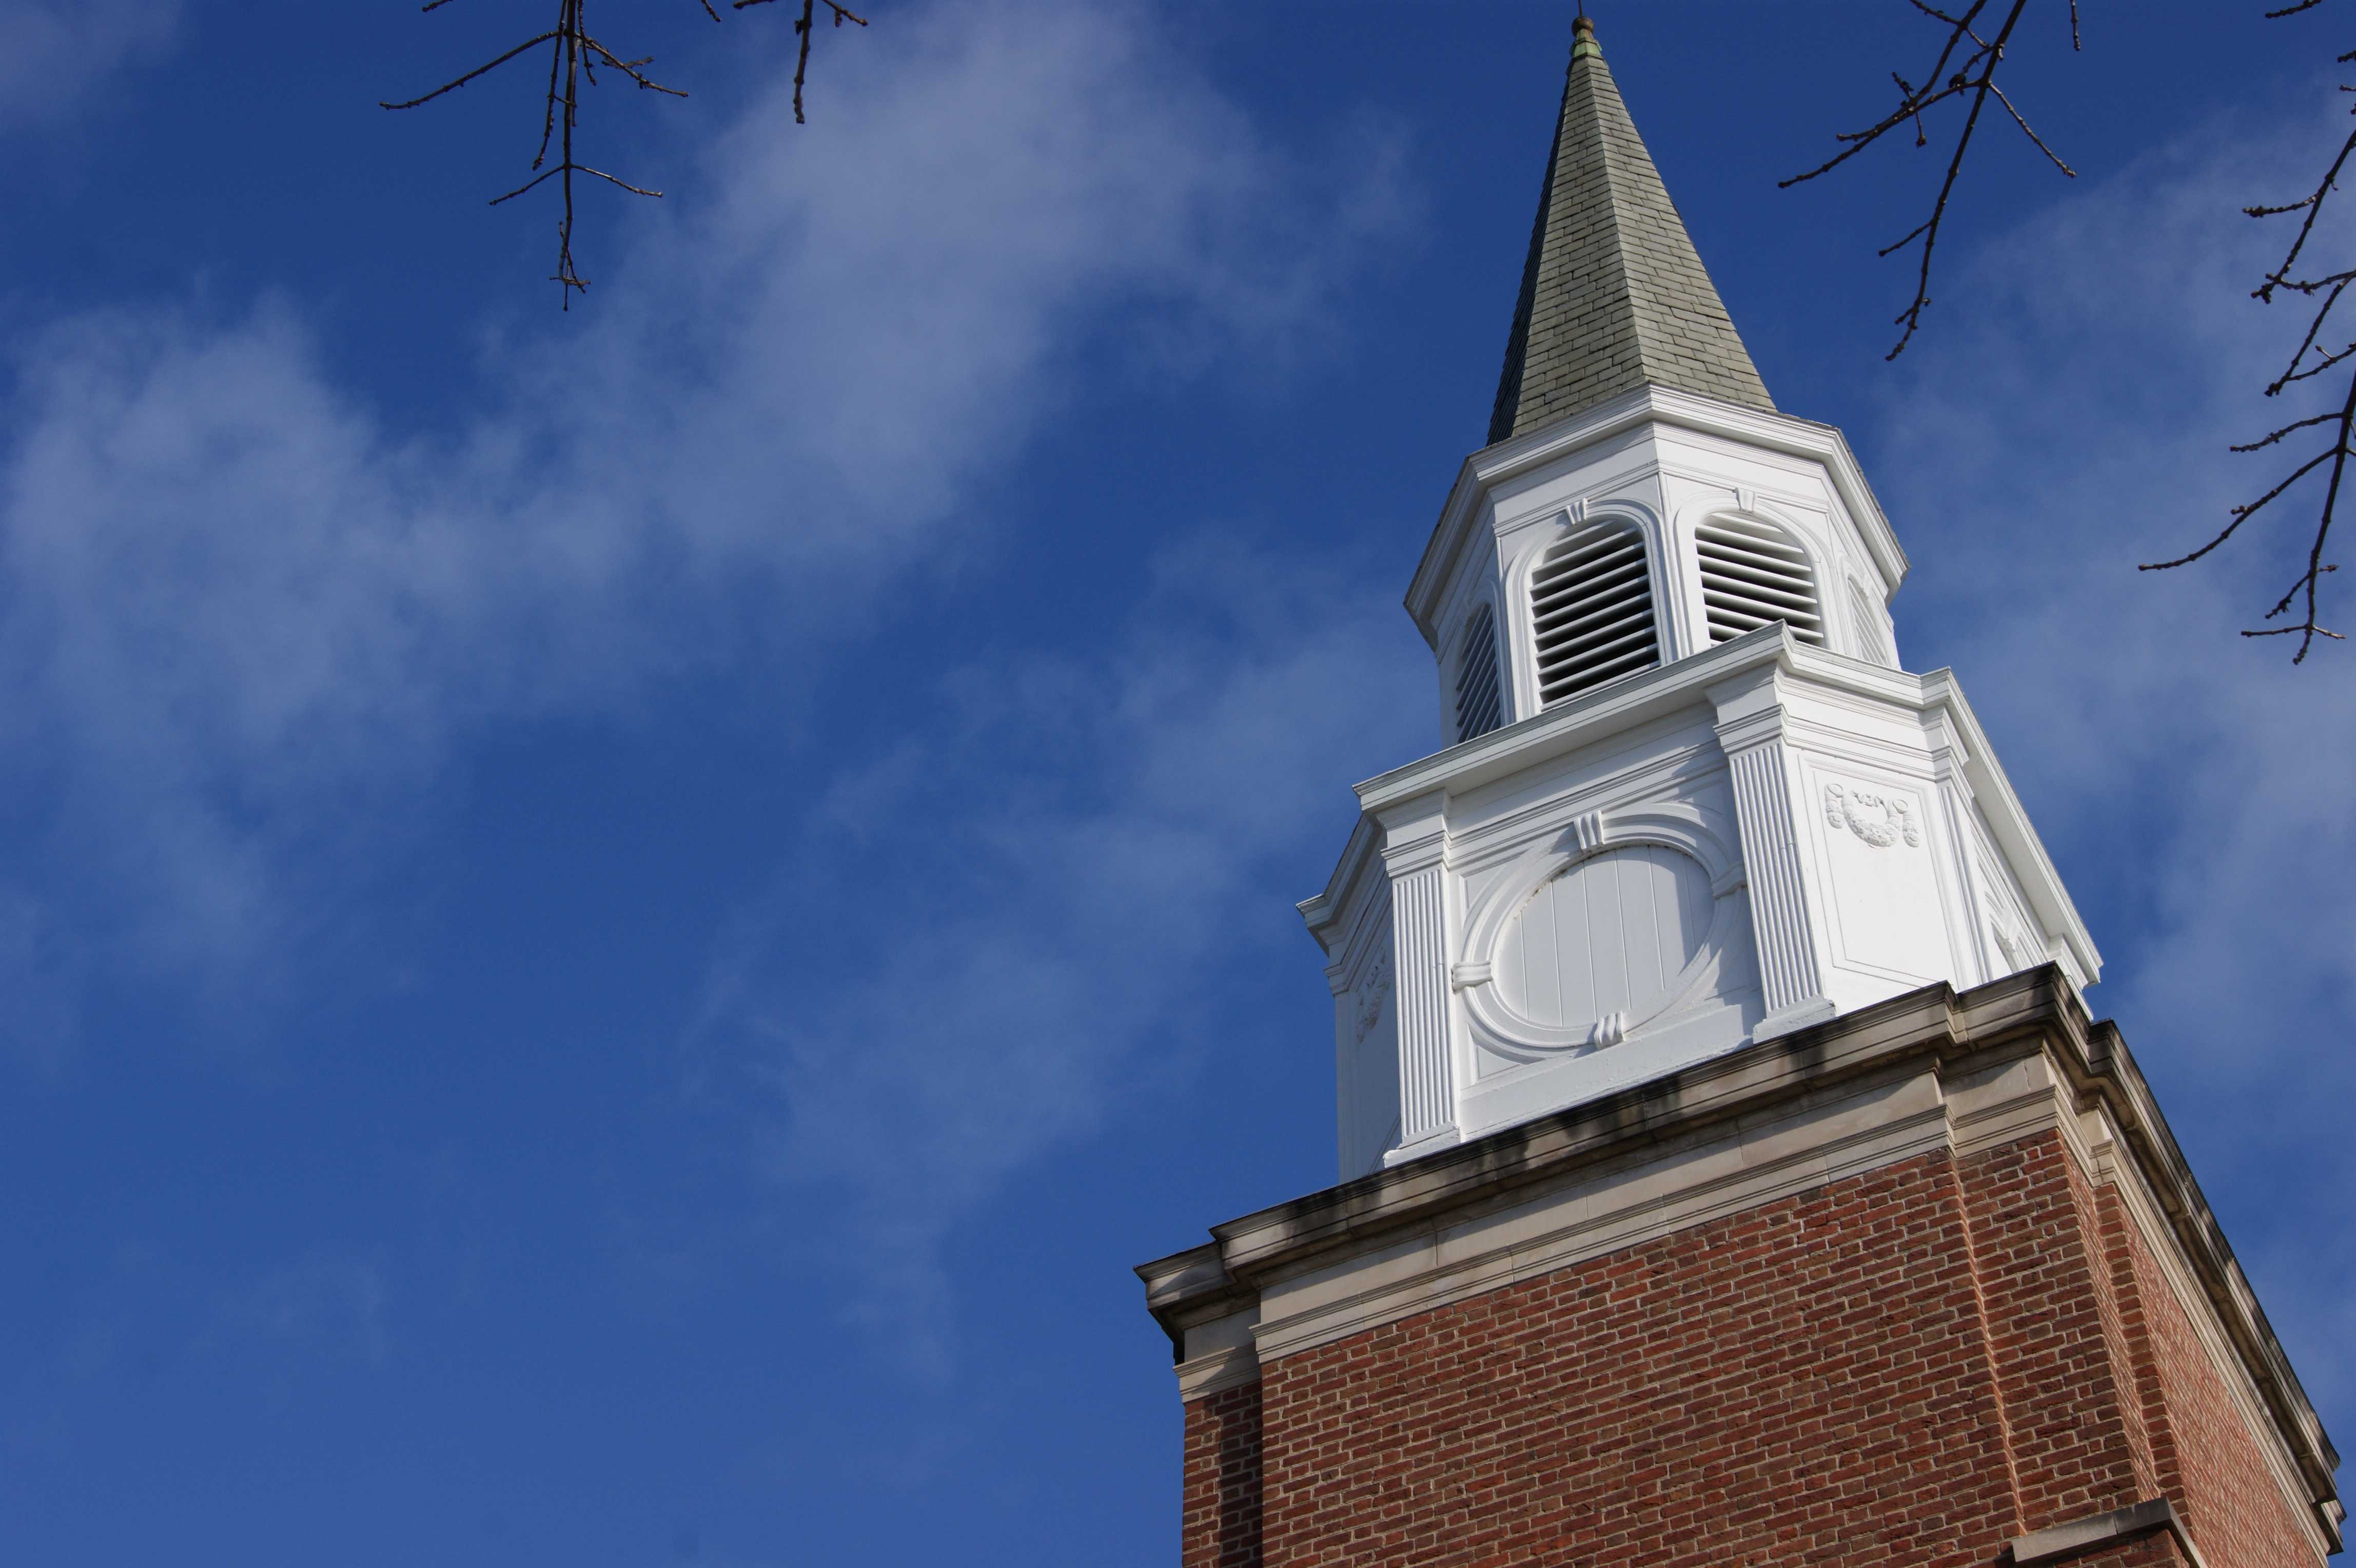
[1489,14,1774,443]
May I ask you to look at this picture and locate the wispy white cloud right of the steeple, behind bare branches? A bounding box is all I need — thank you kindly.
[1871,103,2356,1401]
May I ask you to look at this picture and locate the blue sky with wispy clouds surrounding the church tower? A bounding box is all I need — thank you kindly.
[0,0,2356,1568]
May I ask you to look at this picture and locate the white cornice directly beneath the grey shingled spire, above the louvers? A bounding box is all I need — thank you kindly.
[1406,386,1906,650]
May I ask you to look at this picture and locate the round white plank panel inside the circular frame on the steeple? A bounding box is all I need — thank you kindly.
[1494,843,1711,1029]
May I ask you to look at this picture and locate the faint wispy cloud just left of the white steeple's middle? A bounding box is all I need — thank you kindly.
[683,539,1437,1365]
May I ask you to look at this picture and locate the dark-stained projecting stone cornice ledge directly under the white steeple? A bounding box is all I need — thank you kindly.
[1138,965,2342,1549]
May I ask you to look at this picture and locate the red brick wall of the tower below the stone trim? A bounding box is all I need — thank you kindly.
[1185,1132,2313,1568]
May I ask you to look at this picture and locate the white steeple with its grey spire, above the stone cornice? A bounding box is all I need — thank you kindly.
[1301,24,2102,1175]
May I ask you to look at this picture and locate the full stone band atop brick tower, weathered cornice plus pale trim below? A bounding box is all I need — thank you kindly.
[1138,965,2344,1552]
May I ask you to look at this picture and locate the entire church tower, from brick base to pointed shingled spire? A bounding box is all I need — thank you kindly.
[1138,16,2344,1568]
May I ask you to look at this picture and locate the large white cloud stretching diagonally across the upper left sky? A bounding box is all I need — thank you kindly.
[0,0,1385,1035]
